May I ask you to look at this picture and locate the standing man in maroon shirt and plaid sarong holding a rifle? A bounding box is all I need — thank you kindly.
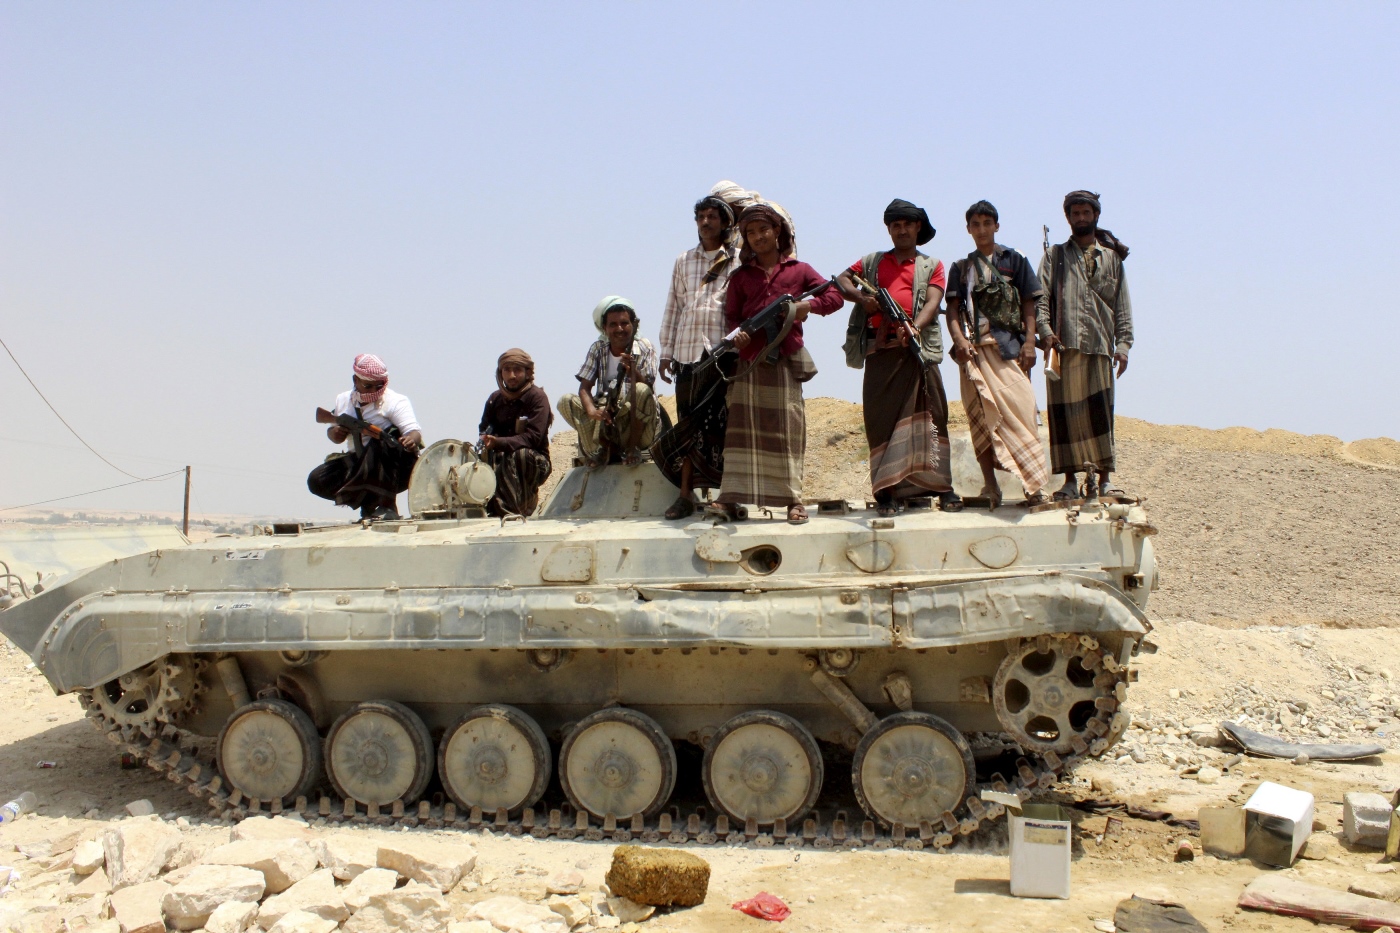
[717,202,844,525]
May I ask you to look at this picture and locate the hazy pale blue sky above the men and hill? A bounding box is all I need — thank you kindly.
[0,0,1400,520]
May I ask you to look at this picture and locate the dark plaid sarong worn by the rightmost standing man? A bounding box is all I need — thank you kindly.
[1046,347,1113,474]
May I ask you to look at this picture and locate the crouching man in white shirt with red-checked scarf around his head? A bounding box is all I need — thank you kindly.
[307,353,423,520]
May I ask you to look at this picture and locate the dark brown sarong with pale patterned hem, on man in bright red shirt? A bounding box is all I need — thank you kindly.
[861,346,953,499]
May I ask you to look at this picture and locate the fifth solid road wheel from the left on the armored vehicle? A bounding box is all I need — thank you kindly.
[701,709,823,827]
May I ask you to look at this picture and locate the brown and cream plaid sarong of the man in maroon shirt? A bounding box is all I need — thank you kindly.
[718,347,816,509]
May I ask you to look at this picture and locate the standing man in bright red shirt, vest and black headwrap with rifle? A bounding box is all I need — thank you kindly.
[836,198,963,516]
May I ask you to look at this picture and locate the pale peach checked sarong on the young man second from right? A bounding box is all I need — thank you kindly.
[958,340,1050,496]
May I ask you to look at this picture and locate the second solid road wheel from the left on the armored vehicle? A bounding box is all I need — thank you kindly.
[326,700,433,807]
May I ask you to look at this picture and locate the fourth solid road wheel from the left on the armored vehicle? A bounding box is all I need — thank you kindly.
[559,706,676,820]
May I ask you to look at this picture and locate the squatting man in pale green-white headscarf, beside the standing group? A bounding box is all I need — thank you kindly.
[559,294,661,467]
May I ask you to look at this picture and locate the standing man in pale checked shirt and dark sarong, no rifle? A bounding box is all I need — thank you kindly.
[657,195,739,520]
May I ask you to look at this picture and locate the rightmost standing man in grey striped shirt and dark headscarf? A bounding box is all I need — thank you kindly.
[1036,191,1133,500]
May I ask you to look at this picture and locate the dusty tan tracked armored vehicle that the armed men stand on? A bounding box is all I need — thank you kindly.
[0,441,1156,848]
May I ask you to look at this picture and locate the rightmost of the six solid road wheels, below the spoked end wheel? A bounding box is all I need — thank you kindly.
[851,713,977,828]
